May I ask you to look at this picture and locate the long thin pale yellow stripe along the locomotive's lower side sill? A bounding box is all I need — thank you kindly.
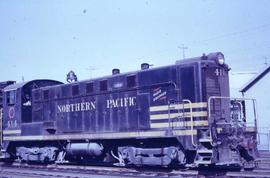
[4,130,197,141]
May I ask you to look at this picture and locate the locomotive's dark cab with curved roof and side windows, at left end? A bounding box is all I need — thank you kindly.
[0,80,61,159]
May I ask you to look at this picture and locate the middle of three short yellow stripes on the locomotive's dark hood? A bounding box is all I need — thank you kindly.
[150,111,207,120]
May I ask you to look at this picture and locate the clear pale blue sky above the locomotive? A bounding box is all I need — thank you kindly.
[0,0,270,88]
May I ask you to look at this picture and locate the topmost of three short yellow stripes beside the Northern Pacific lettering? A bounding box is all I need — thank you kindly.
[150,102,207,112]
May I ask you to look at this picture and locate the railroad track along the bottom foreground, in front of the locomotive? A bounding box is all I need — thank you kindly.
[0,163,270,178]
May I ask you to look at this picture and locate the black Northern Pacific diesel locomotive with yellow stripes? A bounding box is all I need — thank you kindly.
[1,52,256,167]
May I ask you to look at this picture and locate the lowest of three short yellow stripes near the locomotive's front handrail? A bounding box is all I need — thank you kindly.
[150,121,208,128]
